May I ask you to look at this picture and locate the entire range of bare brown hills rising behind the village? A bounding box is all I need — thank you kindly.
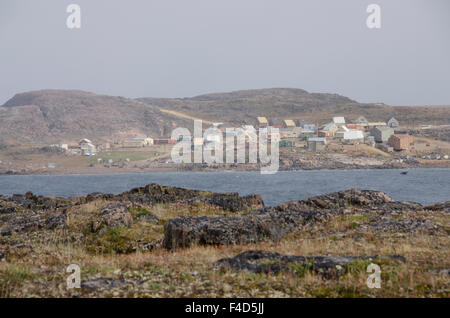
[0,88,450,143]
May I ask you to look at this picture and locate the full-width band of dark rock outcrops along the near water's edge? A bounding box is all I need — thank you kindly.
[0,184,449,252]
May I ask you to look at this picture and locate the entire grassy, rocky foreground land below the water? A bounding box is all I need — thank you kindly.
[0,184,450,297]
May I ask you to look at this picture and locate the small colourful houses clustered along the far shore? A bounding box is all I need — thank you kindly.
[49,116,414,156]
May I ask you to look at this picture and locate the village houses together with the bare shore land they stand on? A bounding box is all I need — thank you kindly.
[0,116,450,174]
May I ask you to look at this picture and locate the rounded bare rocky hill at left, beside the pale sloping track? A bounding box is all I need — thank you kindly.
[0,90,189,143]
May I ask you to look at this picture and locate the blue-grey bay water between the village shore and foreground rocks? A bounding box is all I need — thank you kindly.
[0,169,450,205]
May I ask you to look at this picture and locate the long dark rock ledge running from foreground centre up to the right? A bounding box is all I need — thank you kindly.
[163,189,445,249]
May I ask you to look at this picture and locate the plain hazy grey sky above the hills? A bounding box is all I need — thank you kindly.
[0,0,450,105]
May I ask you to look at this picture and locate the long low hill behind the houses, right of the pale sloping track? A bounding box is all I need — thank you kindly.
[139,88,450,125]
